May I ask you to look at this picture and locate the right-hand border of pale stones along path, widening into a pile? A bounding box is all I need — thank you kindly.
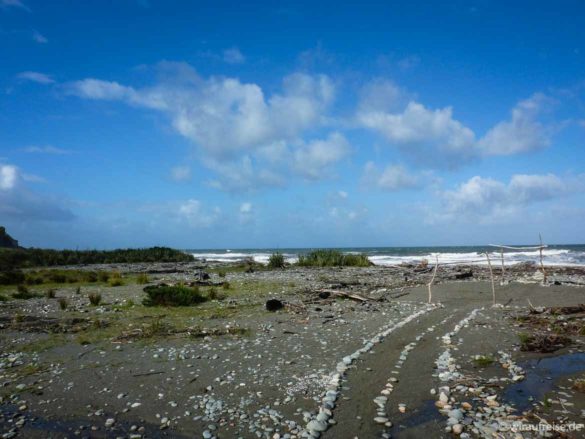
[431,308,525,438]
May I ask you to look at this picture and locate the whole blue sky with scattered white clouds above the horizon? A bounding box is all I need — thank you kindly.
[0,0,585,248]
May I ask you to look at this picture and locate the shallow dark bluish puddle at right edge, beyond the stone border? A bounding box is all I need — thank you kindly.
[504,352,585,411]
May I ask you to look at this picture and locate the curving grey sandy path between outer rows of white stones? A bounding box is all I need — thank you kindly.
[324,308,460,438]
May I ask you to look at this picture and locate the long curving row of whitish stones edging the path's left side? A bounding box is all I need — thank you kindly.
[301,304,438,438]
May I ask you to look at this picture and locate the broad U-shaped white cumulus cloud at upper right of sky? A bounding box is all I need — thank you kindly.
[356,80,552,168]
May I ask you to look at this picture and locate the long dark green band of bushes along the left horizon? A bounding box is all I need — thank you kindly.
[0,247,194,271]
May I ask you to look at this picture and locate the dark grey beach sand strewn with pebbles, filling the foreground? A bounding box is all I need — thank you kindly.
[0,265,585,438]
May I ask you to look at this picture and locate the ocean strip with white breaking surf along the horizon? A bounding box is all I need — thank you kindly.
[186,244,585,266]
